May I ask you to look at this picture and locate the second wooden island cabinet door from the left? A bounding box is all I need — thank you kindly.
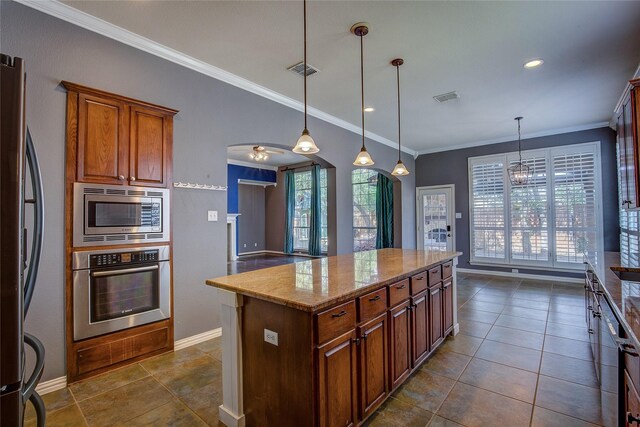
[356,313,389,420]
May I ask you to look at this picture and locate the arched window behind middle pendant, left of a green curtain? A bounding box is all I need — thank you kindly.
[351,169,378,252]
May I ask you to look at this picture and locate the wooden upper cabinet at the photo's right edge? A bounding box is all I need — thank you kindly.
[616,79,640,209]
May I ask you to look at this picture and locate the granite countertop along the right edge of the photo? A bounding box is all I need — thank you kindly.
[587,252,640,348]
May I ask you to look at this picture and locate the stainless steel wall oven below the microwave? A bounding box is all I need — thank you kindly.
[72,246,171,340]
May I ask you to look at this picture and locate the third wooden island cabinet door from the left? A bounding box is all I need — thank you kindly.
[389,300,411,390]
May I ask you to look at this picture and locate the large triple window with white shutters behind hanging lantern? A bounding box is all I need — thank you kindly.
[469,143,602,269]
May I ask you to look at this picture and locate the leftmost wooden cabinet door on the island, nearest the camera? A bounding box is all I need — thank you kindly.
[318,329,358,427]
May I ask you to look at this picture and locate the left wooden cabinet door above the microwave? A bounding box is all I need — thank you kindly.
[77,93,129,185]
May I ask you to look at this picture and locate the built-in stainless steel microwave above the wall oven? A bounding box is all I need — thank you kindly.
[73,182,170,247]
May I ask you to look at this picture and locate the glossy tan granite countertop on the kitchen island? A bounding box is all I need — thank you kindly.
[206,249,462,312]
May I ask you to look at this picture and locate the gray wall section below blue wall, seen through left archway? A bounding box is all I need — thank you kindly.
[238,185,265,254]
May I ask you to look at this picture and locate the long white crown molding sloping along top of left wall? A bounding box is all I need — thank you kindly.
[15,0,416,157]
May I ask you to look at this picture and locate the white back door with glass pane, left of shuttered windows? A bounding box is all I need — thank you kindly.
[416,185,455,251]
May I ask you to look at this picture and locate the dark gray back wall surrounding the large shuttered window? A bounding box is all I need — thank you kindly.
[416,127,620,275]
